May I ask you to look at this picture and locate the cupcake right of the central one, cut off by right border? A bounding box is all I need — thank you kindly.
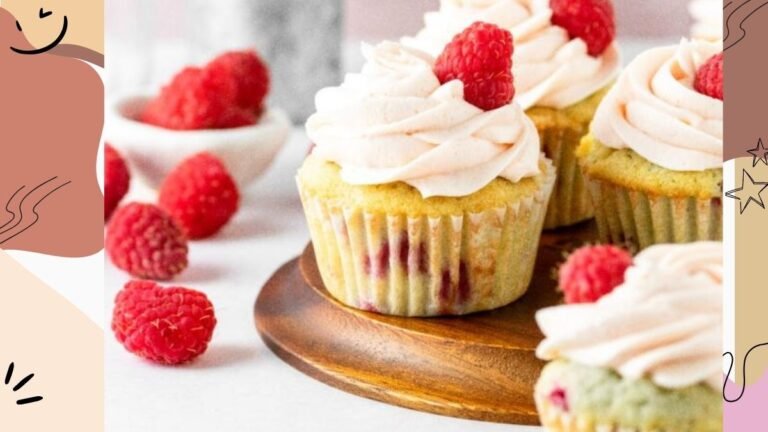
[577,40,723,248]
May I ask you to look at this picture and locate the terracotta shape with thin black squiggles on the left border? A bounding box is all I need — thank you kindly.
[0,8,104,257]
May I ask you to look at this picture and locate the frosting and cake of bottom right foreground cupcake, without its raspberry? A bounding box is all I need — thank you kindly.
[534,242,723,432]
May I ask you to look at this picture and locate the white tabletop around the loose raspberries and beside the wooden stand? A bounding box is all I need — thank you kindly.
[104,131,536,432]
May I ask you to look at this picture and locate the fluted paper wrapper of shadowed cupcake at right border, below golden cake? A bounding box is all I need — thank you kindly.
[585,175,723,249]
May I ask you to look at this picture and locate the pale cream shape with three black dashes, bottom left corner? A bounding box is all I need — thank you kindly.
[0,251,104,432]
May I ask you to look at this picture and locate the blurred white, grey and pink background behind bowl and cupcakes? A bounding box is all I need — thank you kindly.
[105,0,692,124]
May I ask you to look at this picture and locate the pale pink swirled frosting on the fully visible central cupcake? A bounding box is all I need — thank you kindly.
[307,42,541,198]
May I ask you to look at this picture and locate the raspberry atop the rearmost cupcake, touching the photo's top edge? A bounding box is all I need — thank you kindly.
[549,0,616,57]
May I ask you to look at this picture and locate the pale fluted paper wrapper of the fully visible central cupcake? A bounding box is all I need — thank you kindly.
[299,167,554,316]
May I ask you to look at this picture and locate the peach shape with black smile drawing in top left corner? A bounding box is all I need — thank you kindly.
[0,0,104,66]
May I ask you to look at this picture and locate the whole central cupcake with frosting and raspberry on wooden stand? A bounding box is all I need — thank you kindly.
[297,23,555,316]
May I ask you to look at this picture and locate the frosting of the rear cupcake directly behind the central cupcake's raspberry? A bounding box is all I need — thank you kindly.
[403,0,621,110]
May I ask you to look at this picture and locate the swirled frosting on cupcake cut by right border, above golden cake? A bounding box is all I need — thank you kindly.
[591,39,723,171]
